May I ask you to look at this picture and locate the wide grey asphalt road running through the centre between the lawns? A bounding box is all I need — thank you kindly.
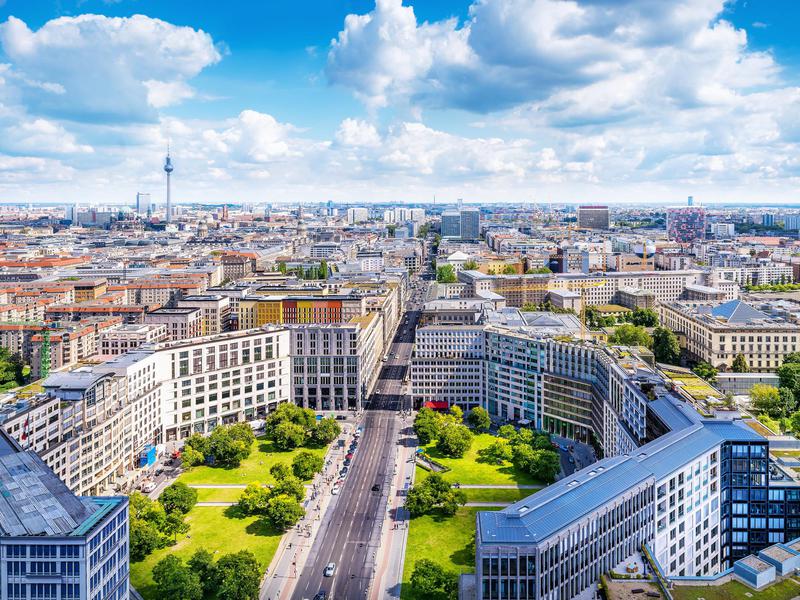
[292,278,428,600]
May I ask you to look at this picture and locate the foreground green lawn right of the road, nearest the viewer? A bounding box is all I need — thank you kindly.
[400,507,491,600]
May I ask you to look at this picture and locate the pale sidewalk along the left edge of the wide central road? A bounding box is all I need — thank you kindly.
[259,425,356,600]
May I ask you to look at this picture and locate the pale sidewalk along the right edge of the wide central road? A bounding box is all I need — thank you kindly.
[369,420,416,600]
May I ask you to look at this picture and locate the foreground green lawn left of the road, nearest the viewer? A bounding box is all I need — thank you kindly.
[131,506,282,600]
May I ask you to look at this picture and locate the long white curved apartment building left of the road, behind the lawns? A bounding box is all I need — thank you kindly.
[0,326,290,494]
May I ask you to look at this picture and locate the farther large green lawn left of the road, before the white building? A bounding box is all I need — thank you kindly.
[178,438,328,485]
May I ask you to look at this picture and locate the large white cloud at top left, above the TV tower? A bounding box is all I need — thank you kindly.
[0,15,221,123]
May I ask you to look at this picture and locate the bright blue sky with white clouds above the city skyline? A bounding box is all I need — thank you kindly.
[0,0,800,205]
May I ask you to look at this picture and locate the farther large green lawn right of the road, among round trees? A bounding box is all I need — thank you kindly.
[417,433,540,485]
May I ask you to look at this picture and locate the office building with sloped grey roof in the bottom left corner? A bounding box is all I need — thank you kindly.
[0,430,130,600]
